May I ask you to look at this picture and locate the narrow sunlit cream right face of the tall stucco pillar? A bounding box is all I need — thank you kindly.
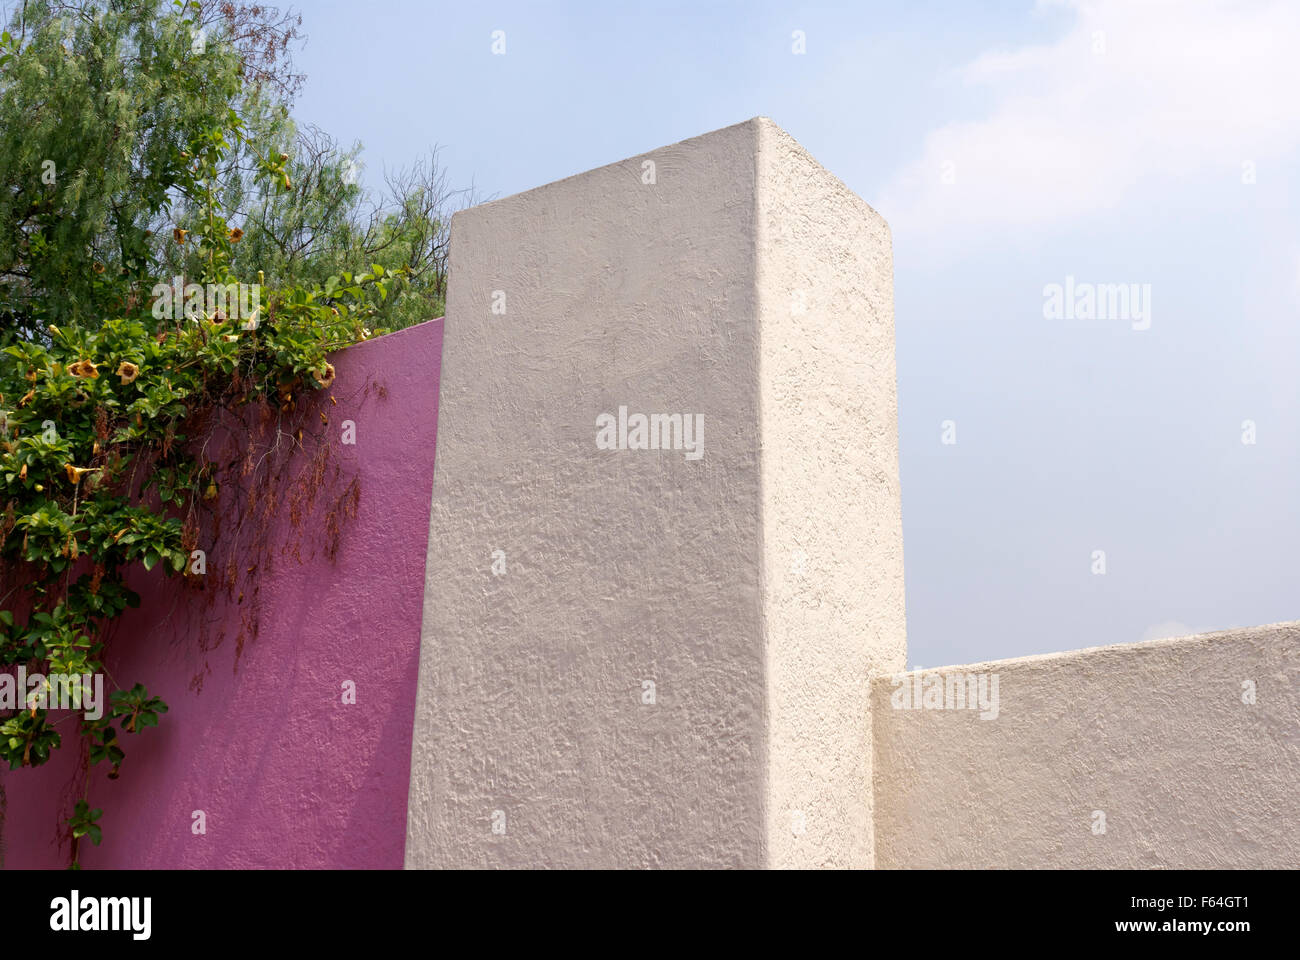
[758,115,906,866]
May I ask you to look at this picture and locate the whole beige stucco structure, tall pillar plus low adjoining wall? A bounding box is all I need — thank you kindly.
[406,113,1300,868]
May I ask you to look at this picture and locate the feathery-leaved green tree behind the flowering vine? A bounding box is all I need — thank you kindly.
[0,0,473,337]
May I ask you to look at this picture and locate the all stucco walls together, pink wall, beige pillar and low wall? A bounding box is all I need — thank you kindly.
[0,118,1300,868]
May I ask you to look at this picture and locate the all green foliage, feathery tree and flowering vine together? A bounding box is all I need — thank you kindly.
[0,0,418,866]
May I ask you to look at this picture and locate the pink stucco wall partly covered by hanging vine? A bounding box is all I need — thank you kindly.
[0,320,442,869]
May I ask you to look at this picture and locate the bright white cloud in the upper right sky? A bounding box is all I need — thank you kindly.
[880,0,1300,232]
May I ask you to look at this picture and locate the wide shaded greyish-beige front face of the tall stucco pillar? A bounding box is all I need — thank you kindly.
[407,115,763,868]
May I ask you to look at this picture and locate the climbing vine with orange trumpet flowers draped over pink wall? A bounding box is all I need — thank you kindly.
[0,3,393,868]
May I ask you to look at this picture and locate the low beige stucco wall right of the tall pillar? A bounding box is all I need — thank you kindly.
[872,623,1300,869]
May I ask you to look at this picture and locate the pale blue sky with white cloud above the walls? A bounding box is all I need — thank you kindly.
[295,0,1300,669]
